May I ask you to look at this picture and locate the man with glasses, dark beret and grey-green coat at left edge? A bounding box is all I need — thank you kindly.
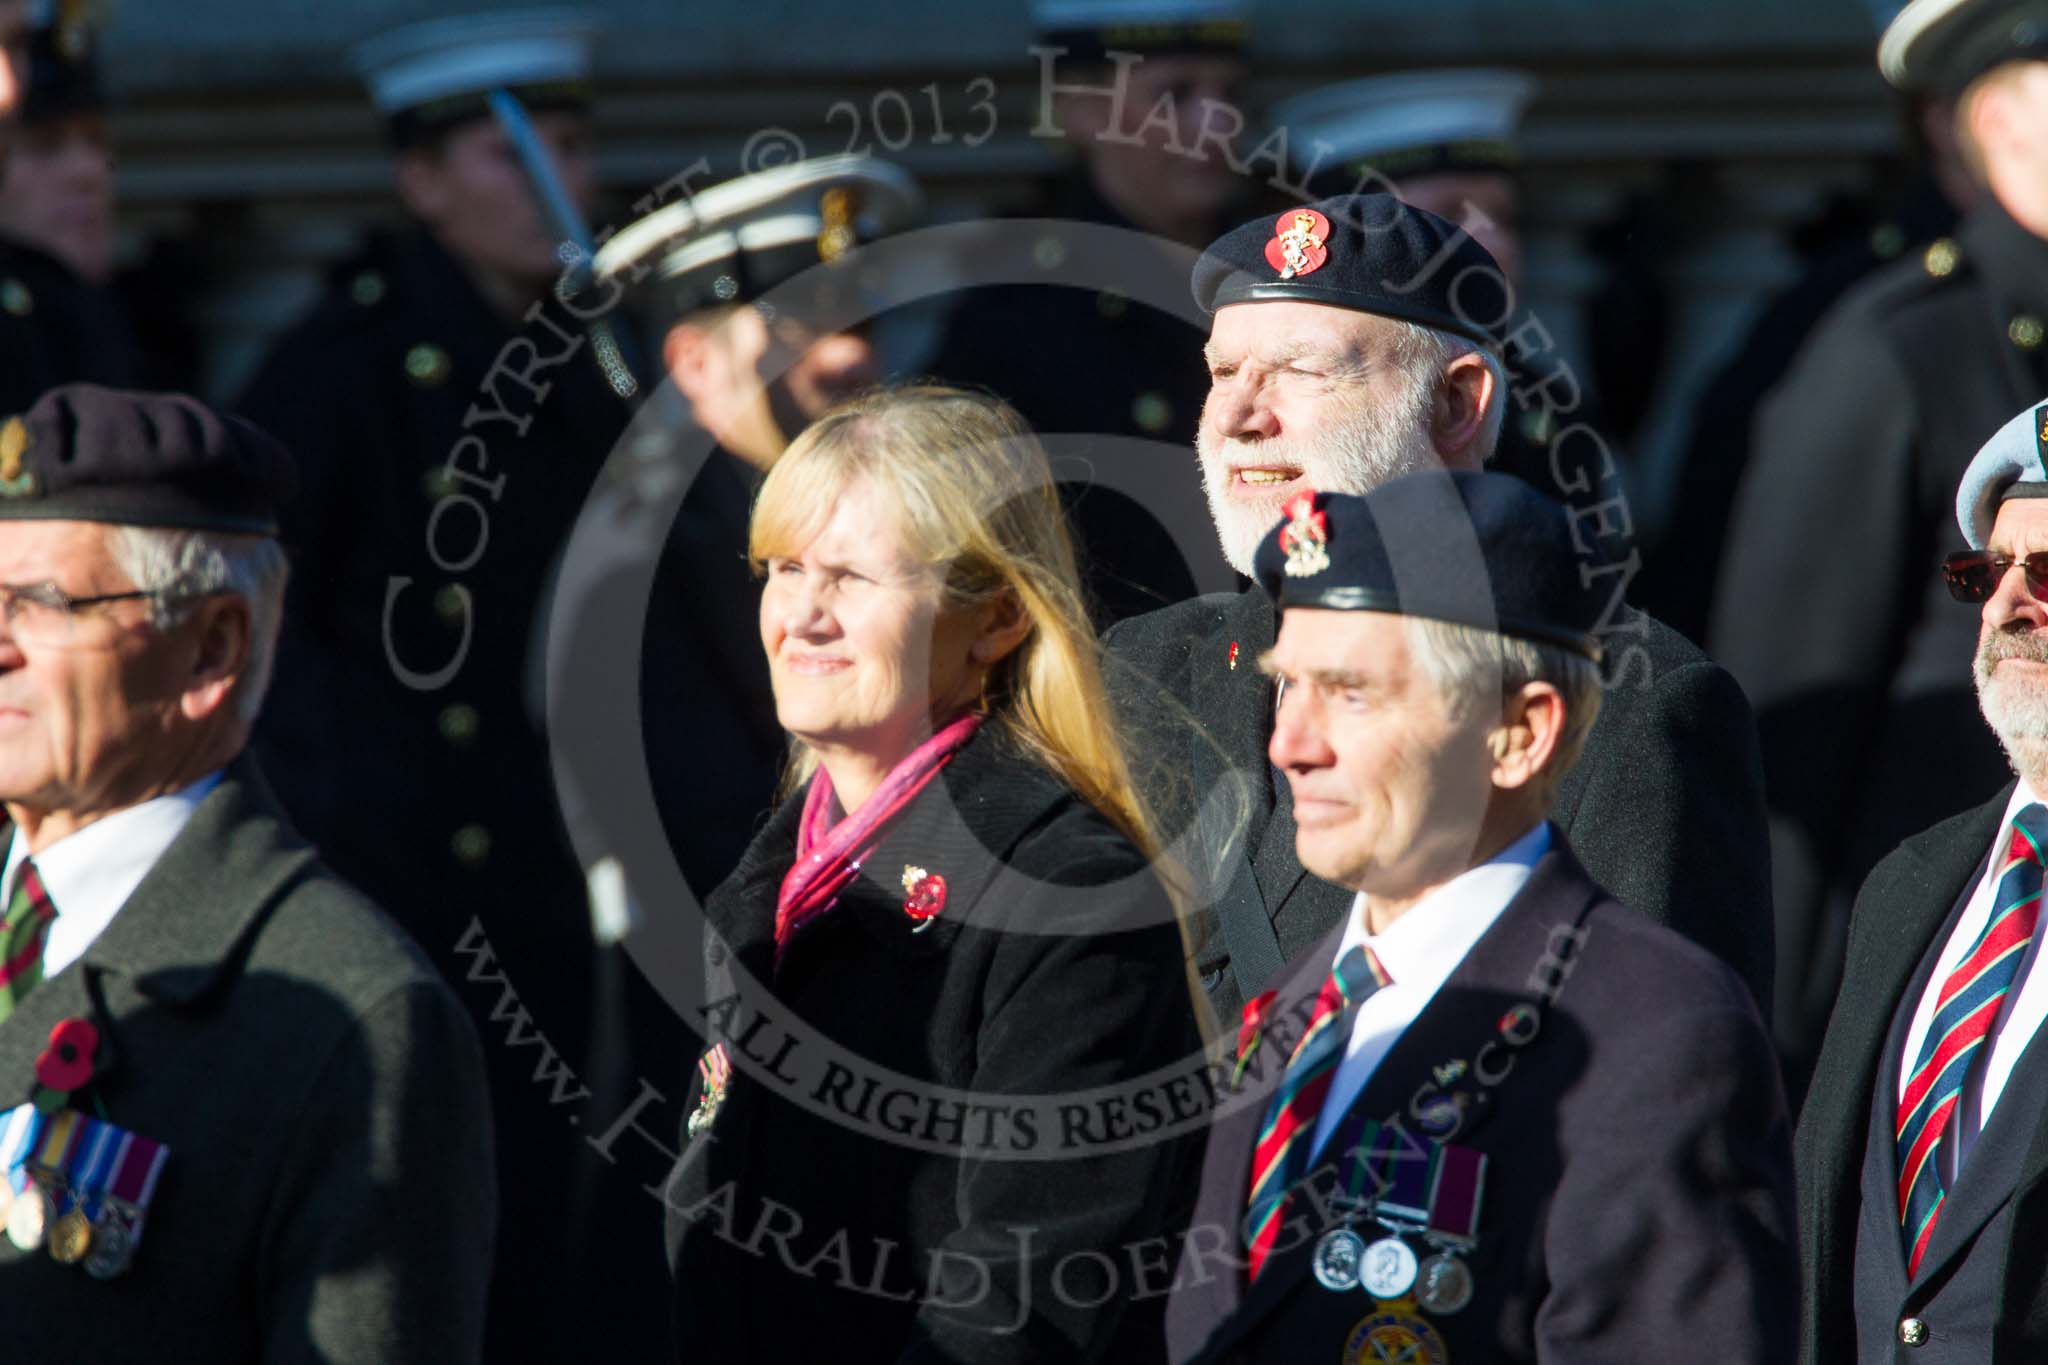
[0,385,496,1365]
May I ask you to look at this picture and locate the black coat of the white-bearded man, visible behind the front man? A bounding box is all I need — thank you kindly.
[1106,589,1772,1023]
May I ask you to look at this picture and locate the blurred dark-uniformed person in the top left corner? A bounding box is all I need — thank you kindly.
[0,0,141,411]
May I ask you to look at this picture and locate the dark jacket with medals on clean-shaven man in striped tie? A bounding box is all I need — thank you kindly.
[1167,841,1796,1365]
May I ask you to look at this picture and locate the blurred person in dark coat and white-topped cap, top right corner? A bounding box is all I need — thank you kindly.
[1710,0,2048,1093]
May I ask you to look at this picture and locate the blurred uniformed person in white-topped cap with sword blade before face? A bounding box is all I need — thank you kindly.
[240,10,666,1359]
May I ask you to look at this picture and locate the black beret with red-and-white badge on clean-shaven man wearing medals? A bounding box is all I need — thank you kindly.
[1253,471,1608,659]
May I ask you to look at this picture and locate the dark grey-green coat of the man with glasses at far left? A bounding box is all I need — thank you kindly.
[0,759,496,1365]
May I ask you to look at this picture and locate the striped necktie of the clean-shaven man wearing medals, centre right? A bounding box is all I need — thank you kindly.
[1245,943,1389,1279]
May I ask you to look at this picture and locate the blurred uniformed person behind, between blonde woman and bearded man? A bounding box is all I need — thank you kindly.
[932,0,1255,624]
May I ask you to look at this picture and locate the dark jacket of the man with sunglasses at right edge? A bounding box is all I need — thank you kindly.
[1798,784,2048,1365]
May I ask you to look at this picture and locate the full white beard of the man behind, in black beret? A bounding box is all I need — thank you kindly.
[1194,383,1438,577]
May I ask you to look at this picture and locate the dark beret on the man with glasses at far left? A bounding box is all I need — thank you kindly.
[0,385,295,536]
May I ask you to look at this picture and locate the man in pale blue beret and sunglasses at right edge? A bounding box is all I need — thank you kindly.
[1798,397,2048,1365]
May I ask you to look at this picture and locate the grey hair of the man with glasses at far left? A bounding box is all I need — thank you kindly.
[106,526,291,720]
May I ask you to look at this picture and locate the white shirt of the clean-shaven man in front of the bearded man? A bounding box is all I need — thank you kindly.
[1311,821,1550,1156]
